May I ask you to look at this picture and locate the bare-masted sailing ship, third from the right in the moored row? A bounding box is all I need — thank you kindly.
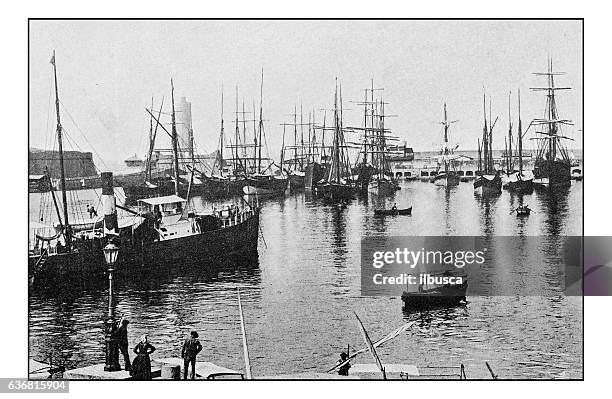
[474,95,502,195]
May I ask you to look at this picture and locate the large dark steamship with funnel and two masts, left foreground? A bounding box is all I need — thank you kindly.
[28,52,259,283]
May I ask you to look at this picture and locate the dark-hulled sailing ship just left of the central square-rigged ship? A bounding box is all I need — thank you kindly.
[315,81,355,202]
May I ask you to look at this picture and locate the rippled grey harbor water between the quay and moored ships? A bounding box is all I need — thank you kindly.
[29,181,583,378]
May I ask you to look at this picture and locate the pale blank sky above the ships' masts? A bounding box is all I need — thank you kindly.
[30,21,582,169]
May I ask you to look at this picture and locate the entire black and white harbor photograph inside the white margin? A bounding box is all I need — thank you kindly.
[27,19,588,380]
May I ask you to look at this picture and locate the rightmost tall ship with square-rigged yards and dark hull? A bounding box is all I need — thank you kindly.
[531,59,573,188]
